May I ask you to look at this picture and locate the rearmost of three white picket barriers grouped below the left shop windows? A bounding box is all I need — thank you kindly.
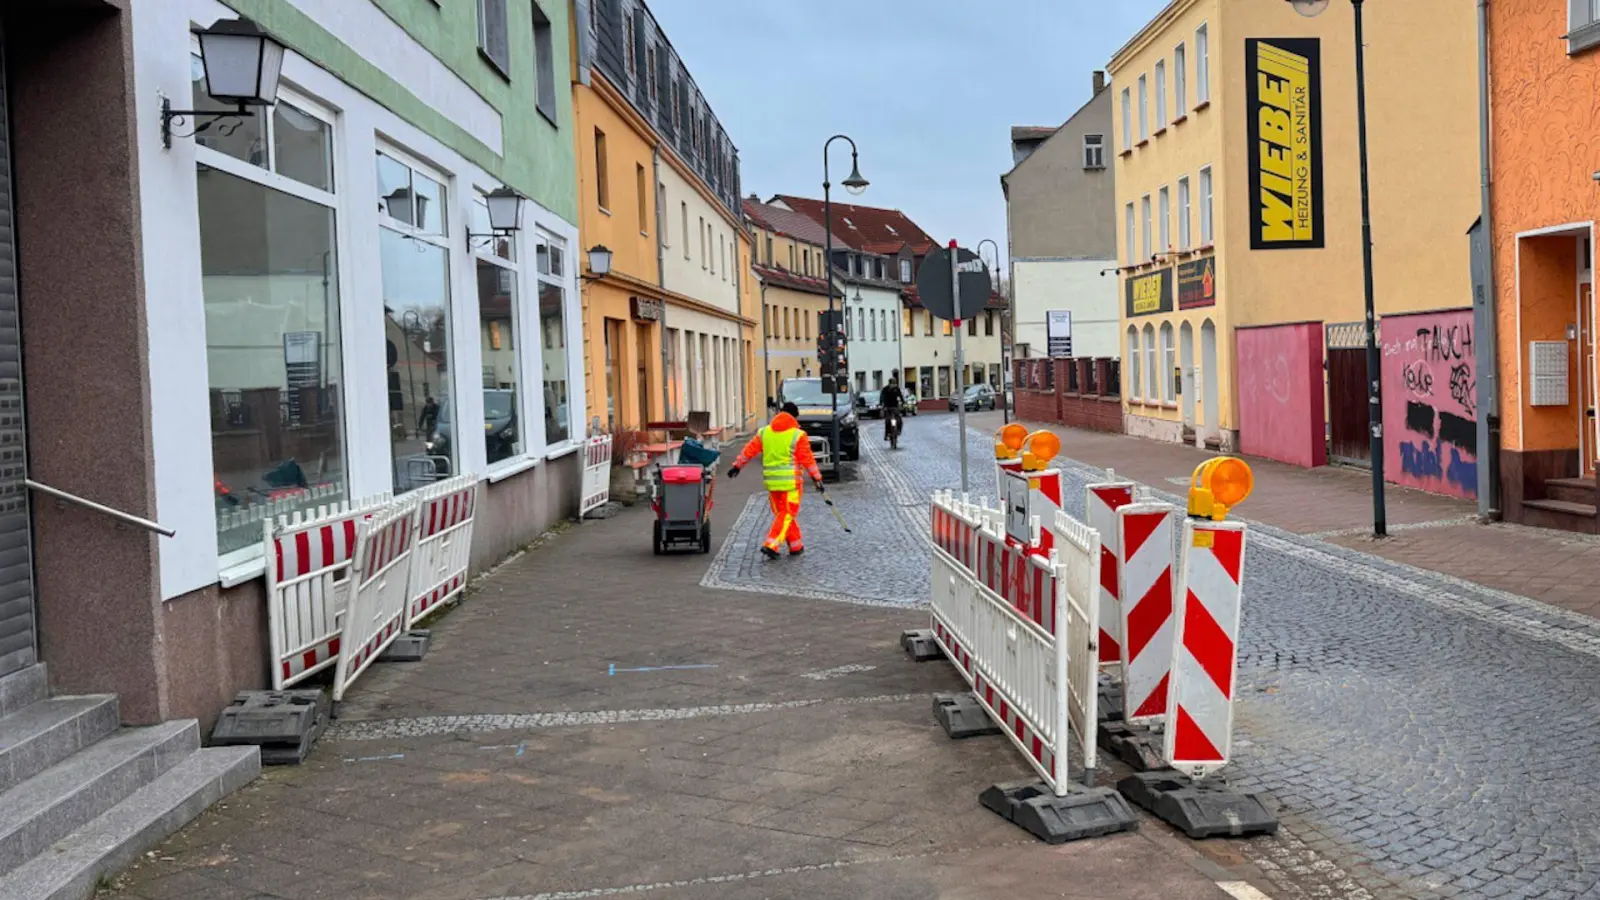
[405,474,476,629]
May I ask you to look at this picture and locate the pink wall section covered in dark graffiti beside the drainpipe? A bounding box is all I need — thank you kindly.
[1379,309,1478,500]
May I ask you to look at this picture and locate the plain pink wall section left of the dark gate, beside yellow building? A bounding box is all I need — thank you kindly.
[1234,322,1328,468]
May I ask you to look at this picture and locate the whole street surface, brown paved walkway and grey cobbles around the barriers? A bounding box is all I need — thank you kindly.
[103,416,1600,900]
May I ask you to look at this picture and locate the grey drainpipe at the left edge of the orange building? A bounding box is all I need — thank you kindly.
[1472,0,1501,520]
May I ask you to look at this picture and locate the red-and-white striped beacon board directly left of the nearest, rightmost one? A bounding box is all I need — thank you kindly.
[1117,503,1178,722]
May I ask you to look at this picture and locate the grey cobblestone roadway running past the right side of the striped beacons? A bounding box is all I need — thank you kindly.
[896,416,1600,900]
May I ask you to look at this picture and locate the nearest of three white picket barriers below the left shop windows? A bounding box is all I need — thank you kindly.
[262,495,392,690]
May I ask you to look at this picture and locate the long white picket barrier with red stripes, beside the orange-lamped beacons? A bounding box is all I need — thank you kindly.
[931,492,1099,796]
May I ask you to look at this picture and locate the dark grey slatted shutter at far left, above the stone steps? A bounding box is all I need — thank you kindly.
[0,45,35,676]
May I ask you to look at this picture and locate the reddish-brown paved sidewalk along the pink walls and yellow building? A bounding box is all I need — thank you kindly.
[1004,413,1600,617]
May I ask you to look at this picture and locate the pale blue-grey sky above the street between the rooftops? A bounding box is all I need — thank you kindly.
[648,0,1166,265]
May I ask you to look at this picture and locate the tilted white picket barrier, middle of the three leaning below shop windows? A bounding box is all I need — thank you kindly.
[333,496,418,703]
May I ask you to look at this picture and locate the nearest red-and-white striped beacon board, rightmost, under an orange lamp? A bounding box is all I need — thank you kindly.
[1165,519,1245,778]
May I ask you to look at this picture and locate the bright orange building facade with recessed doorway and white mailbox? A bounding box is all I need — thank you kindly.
[1488,0,1600,533]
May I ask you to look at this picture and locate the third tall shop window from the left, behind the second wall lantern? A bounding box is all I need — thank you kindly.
[469,194,528,466]
